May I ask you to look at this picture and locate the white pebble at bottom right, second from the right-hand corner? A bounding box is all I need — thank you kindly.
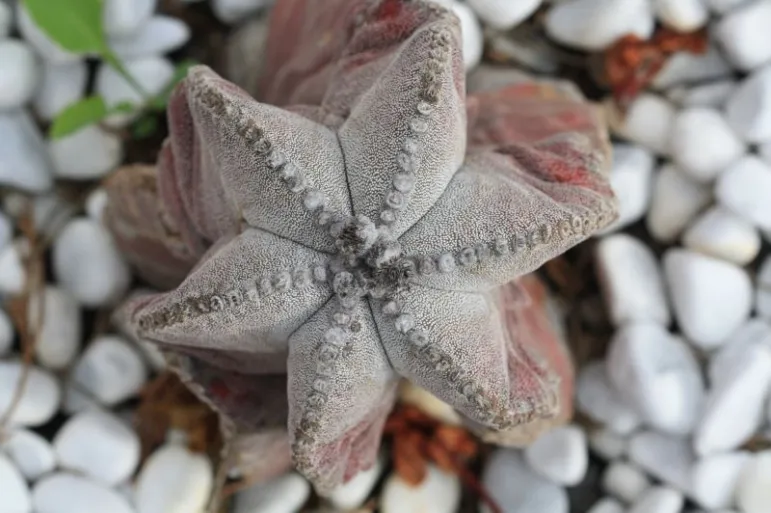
[688,452,750,510]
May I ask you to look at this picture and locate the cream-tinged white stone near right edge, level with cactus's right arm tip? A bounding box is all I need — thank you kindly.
[683,206,761,265]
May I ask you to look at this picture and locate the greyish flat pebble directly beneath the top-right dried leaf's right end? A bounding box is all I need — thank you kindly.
[651,46,733,89]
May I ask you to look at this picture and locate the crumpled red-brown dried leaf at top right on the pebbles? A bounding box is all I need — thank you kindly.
[603,27,708,109]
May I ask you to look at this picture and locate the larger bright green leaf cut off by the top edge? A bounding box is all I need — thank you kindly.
[23,0,107,54]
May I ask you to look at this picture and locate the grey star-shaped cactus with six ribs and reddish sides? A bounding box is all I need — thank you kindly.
[107,0,615,491]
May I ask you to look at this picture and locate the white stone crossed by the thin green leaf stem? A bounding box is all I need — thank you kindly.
[95,57,174,127]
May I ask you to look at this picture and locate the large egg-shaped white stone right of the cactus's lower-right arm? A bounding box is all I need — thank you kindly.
[606,321,704,435]
